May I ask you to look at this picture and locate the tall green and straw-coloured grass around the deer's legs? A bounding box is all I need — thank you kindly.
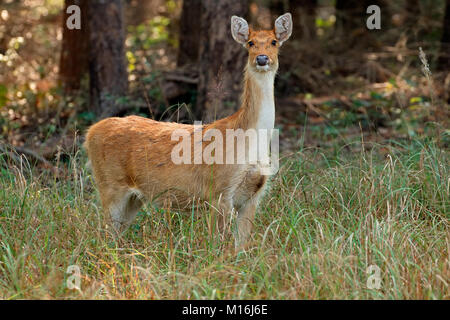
[0,141,450,299]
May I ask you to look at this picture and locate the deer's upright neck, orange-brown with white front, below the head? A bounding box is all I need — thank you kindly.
[236,69,275,130]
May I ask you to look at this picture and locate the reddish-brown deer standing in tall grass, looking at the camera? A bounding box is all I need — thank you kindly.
[84,13,292,250]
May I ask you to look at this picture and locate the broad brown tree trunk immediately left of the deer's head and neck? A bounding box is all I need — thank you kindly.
[197,0,248,122]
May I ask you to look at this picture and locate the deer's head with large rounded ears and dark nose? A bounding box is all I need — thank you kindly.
[231,13,292,72]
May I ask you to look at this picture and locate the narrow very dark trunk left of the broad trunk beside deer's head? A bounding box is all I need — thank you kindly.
[177,0,202,67]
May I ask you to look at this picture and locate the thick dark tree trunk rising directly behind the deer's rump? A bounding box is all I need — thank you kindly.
[88,0,128,117]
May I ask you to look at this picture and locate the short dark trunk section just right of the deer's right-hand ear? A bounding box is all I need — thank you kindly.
[289,0,317,40]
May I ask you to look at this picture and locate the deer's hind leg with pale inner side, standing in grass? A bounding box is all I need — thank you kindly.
[100,187,143,237]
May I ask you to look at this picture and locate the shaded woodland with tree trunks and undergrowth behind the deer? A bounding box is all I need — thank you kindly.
[0,0,450,161]
